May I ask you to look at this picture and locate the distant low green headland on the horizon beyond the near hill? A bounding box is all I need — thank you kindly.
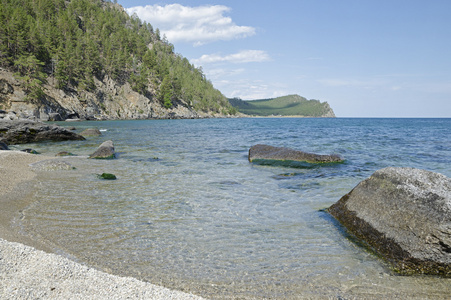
[229,95,335,118]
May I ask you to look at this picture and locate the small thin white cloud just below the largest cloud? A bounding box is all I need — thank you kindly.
[192,50,270,65]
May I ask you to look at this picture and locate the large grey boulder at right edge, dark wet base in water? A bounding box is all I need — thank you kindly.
[328,168,451,276]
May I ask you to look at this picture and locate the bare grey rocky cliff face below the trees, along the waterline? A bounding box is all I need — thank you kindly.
[0,69,222,121]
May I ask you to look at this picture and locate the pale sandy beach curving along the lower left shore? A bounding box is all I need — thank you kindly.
[0,151,202,299]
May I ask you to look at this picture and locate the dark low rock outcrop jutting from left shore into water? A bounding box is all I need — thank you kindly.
[0,119,84,145]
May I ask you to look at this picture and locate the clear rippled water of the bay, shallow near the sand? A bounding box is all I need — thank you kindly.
[17,118,451,299]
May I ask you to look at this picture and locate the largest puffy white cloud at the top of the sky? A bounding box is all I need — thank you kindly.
[126,4,255,45]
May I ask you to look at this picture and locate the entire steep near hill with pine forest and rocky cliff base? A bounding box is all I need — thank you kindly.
[0,0,235,120]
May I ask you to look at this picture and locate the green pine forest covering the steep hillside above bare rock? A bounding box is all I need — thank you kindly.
[0,0,234,114]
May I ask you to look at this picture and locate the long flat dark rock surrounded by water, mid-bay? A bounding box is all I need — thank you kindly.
[249,144,343,163]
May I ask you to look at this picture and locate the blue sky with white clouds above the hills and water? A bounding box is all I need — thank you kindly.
[118,0,451,117]
